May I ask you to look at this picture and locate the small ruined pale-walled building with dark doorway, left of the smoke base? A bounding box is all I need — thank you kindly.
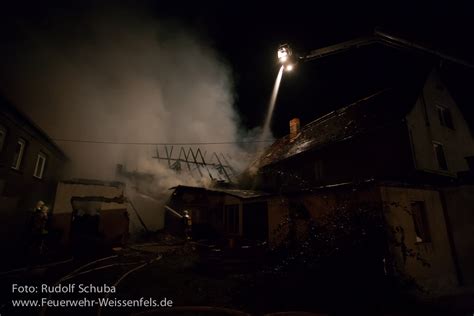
[51,179,130,247]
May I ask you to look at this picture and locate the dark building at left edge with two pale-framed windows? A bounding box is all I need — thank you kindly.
[0,98,67,254]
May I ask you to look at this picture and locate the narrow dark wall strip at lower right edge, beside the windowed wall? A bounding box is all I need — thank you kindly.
[443,185,474,286]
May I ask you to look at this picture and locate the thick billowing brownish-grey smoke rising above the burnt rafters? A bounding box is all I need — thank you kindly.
[3,4,260,232]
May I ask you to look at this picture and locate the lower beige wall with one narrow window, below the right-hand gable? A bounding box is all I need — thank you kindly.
[380,186,458,295]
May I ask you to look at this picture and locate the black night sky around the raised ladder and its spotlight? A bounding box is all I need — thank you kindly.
[1,1,474,136]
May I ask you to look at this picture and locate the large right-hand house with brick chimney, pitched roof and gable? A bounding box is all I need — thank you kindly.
[256,70,474,294]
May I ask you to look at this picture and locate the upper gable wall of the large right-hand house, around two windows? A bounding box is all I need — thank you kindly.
[406,70,474,177]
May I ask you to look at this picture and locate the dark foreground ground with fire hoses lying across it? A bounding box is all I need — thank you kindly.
[0,242,472,316]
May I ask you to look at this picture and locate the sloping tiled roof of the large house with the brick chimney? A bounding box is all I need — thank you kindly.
[255,87,420,168]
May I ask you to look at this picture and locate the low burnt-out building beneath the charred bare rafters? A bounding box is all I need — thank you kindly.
[165,186,288,244]
